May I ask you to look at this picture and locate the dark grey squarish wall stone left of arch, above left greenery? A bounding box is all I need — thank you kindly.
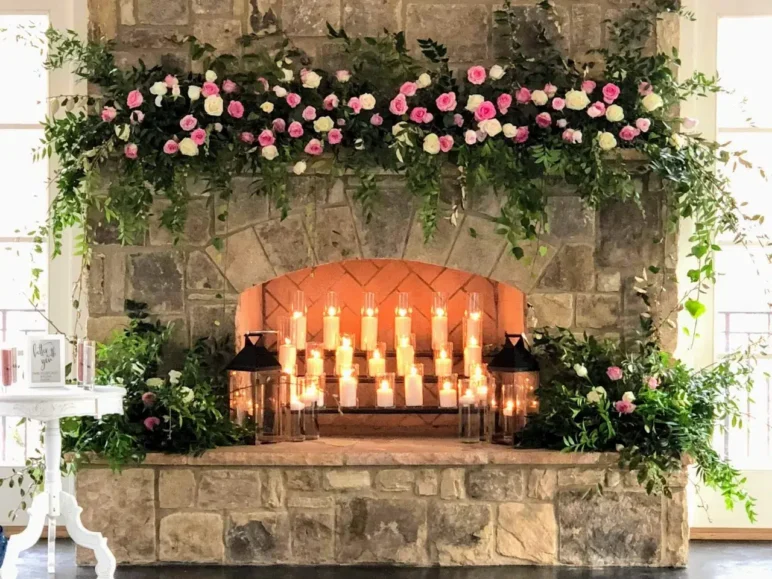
[128,251,184,314]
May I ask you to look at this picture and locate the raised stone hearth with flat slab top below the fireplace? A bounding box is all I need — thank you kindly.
[77,438,688,567]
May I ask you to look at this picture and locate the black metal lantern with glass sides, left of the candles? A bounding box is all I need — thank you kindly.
[225,331,282,443]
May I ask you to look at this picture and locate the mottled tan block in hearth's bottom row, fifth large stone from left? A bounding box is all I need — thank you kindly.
[428,501,495,565]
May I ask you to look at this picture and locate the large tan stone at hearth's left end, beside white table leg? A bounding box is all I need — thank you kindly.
[75,468,156,565]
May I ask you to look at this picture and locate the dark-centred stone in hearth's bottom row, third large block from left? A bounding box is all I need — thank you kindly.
[225,511,292,565]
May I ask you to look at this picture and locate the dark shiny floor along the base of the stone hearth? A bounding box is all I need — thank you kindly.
[10,541,772,579]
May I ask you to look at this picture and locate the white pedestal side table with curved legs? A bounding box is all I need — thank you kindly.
[0,386,126,579]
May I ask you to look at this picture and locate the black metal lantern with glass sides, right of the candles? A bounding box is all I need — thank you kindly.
[488,334,539,444]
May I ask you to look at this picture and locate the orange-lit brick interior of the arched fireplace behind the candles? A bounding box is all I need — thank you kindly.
[231,259,526,437]
